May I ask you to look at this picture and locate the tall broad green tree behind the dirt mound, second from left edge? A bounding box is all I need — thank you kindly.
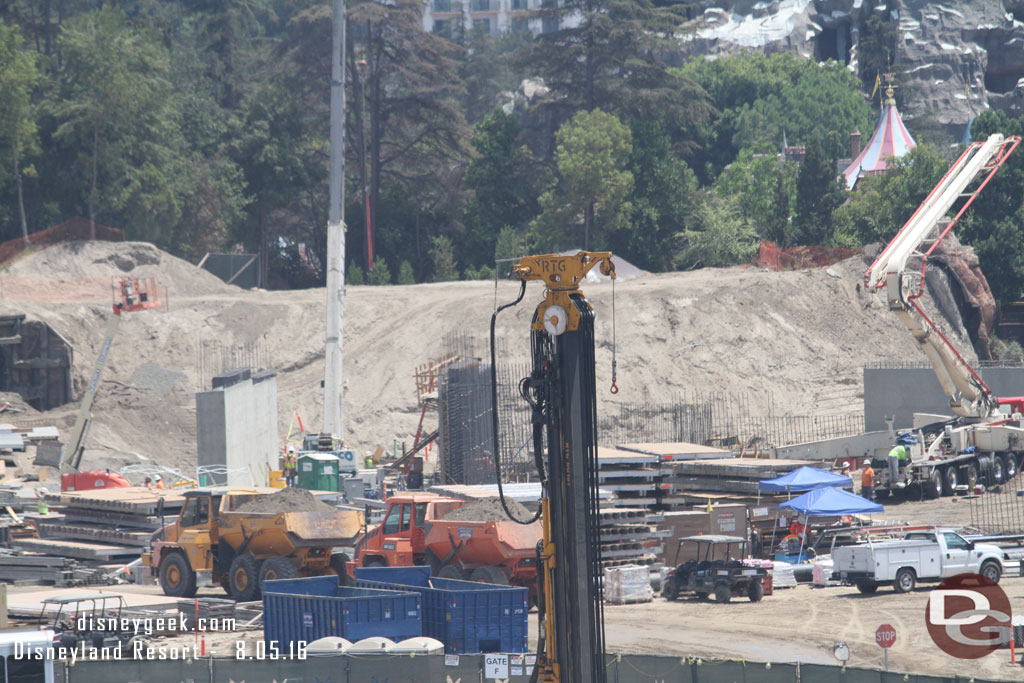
[49,6,187,241]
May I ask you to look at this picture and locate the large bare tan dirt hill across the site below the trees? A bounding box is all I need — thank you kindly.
[0,242,973,479]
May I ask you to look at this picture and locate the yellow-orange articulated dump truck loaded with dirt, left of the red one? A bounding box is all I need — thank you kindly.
[142,487,365,602]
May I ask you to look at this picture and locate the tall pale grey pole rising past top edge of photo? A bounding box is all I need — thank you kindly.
[324,0,345,439]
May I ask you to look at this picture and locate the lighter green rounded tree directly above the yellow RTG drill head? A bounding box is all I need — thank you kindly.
[530,110,633,249]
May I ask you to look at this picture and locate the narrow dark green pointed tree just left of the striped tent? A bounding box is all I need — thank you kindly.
[784,136,846,247]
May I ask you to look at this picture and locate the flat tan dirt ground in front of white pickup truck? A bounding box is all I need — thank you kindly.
[530,577,1024,680]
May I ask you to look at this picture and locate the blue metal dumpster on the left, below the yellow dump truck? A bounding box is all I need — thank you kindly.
[263,577,423,652]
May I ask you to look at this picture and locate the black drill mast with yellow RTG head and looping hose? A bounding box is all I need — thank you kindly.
[490,251,615,683]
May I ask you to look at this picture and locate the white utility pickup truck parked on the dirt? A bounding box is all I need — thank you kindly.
[831,529,1005,593]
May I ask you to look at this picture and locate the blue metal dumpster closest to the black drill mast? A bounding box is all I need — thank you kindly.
[355,566,529,654]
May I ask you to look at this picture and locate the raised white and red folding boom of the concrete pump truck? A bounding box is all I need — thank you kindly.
[864,134,1021,418]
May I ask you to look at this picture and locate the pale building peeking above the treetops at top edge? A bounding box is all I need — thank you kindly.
[423,0,558,38]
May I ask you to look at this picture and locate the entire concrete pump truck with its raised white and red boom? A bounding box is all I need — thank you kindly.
[864,134,1024,498]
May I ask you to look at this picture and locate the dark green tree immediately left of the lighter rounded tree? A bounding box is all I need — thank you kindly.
[459,110,550,266]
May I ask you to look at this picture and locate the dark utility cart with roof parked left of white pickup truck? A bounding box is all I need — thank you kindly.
[662,536,768,602]
